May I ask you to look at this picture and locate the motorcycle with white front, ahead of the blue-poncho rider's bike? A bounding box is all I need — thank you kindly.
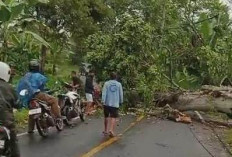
[58,82,85,126]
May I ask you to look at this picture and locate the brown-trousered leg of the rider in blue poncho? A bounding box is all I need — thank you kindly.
[35,92,61,118]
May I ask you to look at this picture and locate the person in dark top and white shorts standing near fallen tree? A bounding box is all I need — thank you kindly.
[85,70,94,114]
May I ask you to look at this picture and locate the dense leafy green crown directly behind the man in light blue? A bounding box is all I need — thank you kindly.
[87,14,165,104]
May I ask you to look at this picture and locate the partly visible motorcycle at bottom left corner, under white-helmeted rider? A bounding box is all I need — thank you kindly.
[0,126,11,157]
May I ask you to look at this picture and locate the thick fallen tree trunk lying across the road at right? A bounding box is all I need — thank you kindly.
[155,86,232,115]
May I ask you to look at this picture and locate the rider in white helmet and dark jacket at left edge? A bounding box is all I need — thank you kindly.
[0,62,20,157]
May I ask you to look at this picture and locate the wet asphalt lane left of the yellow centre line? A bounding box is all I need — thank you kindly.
[18,116,135,157]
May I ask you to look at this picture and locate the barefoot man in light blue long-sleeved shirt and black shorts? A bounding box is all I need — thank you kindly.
[102,72,123,137]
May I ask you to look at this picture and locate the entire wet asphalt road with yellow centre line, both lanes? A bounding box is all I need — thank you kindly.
[19,116,228,157]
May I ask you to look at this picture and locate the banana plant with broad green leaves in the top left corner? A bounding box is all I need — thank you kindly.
[0,0,50,61]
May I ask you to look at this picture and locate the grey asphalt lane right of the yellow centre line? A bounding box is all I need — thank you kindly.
[96,121,210,157]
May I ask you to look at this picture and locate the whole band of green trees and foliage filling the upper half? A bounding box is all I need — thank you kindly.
[0,0,232,105]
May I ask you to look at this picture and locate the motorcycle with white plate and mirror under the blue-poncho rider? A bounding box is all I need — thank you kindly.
[20,90,64,137]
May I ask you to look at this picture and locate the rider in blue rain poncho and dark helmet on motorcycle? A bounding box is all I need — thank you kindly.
[17,59,62,133]
